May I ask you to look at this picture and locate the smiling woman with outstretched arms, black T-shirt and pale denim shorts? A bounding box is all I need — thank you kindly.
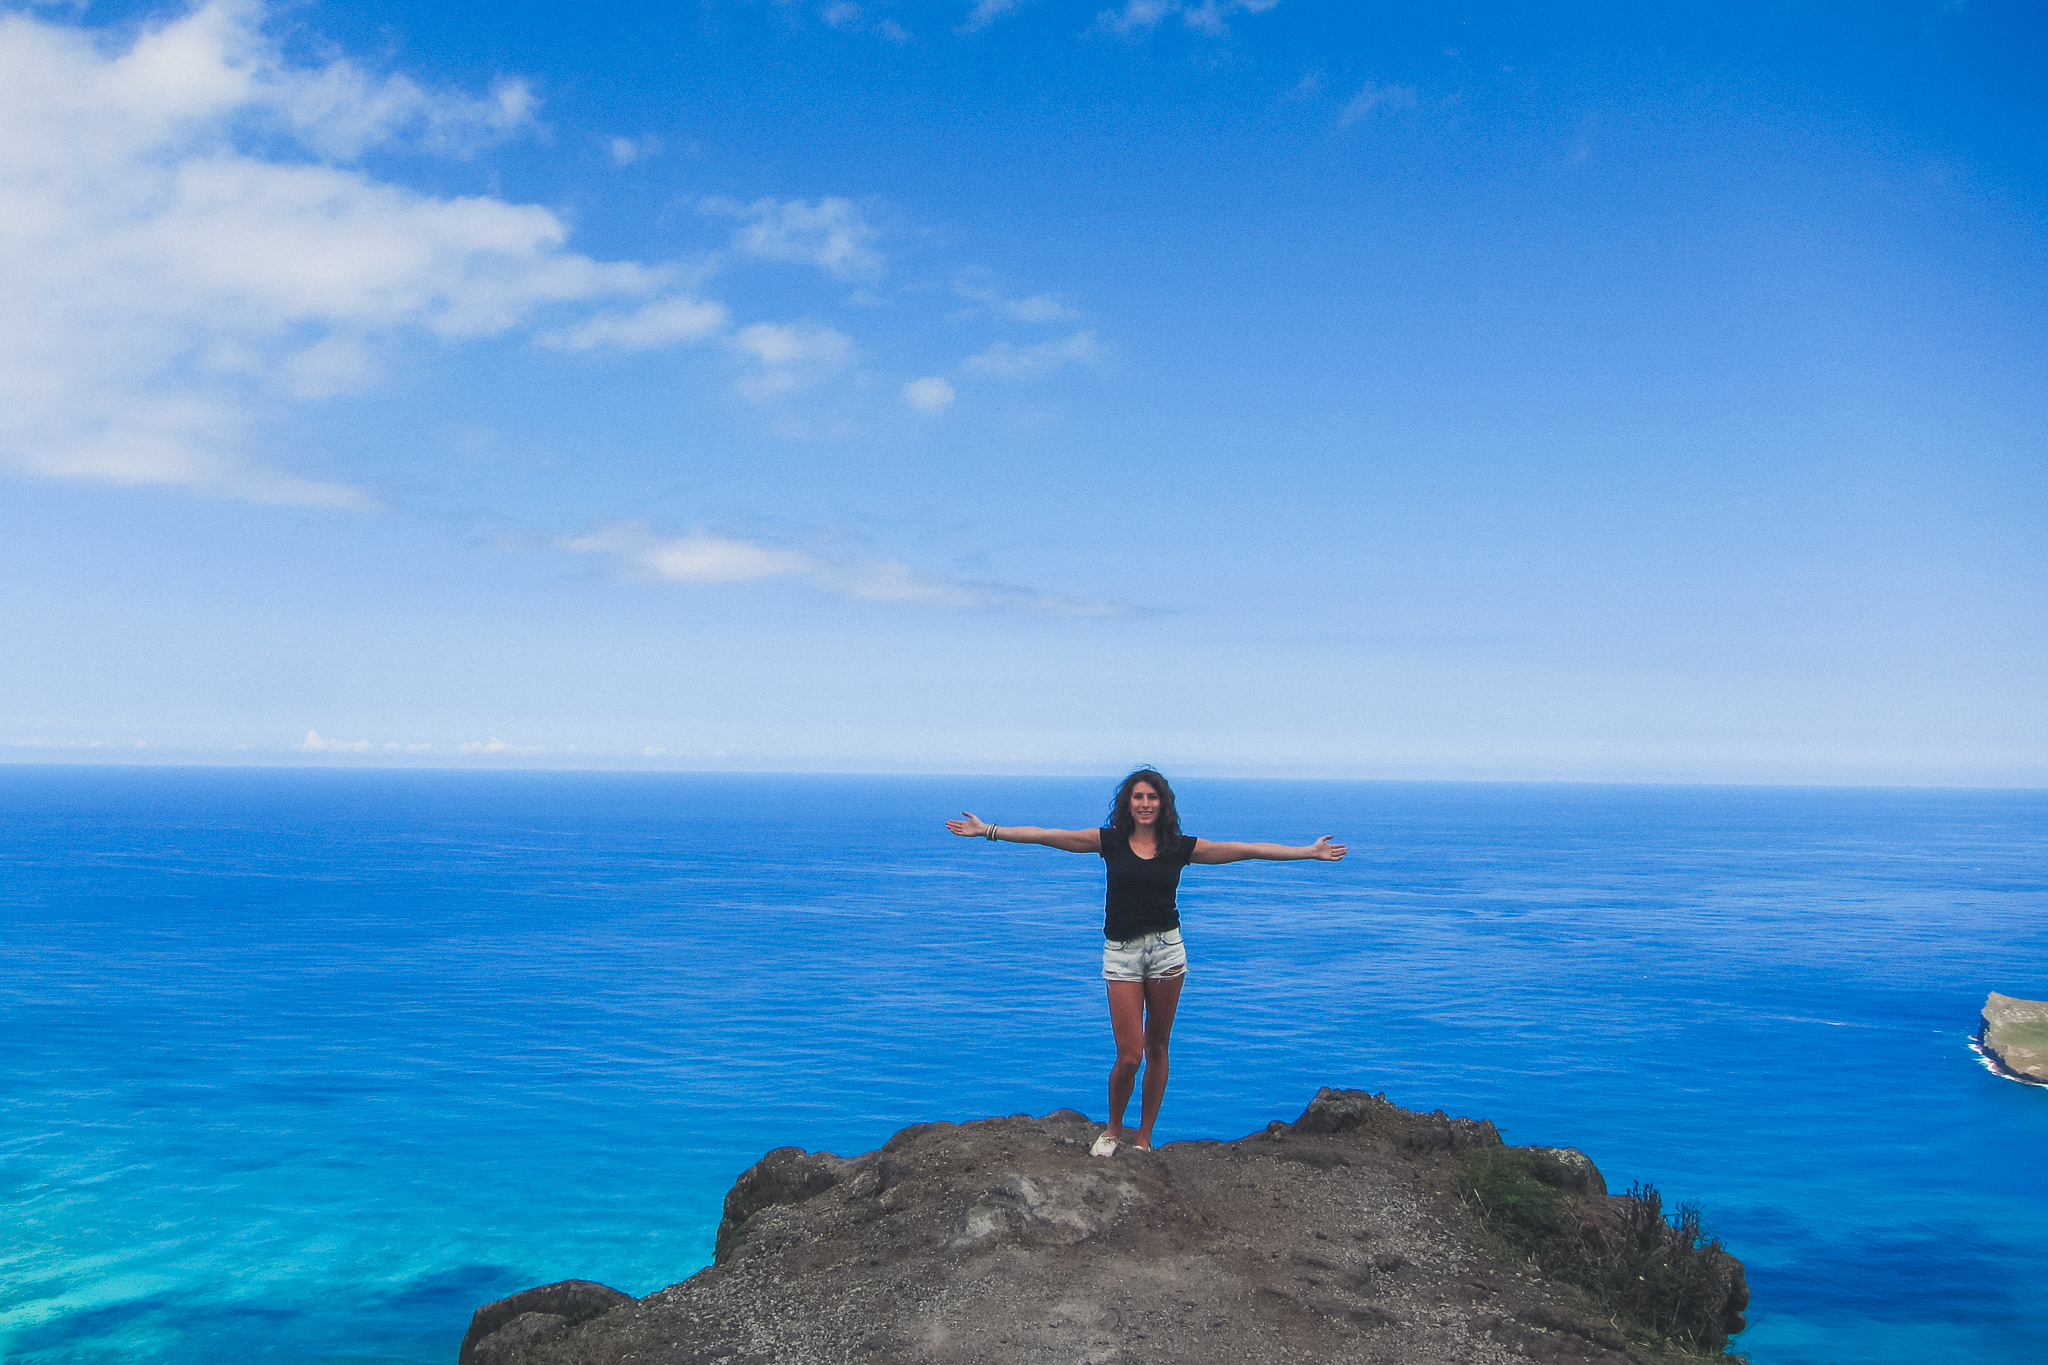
[946,767,1346,1156]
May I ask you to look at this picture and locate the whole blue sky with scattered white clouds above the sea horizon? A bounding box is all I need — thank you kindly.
[0,0,2048,784]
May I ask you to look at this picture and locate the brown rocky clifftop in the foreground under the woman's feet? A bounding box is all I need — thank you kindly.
[461,1089,1749,1365]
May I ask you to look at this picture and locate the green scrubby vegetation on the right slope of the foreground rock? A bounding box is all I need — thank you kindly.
[1458,1148,1747,1359]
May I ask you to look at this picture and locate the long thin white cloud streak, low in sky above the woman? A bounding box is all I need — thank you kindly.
[555,526,1130,616]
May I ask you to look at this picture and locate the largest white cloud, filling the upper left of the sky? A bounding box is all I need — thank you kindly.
[0,0,666,508]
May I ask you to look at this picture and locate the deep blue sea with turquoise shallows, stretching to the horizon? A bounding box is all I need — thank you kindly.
[0,767,2048,1365]
